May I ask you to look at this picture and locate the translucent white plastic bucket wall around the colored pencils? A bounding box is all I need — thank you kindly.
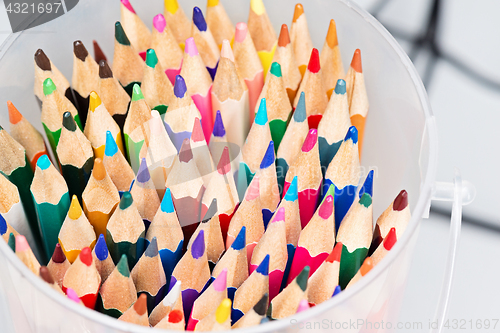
[0,0,437,333]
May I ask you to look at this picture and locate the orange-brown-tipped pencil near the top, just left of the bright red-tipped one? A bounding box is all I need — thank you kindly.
[273,24,302,104]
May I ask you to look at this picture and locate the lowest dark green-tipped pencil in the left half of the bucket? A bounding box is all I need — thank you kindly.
[96,255,137,318]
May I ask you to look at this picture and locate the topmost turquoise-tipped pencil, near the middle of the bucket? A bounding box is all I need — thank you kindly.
[237,98,272,200]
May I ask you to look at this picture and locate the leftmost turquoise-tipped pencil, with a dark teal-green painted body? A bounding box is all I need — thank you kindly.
[30,155,70,258]
